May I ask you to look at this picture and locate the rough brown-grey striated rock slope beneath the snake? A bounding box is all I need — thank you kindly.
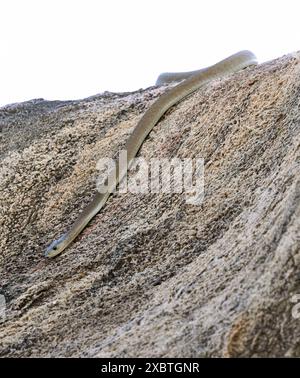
[0,53,300,357]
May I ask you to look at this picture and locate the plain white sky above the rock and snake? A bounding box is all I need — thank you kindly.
[0,0,300,106]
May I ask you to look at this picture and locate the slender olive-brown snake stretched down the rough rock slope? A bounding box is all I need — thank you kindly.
[45,50,257,258]
